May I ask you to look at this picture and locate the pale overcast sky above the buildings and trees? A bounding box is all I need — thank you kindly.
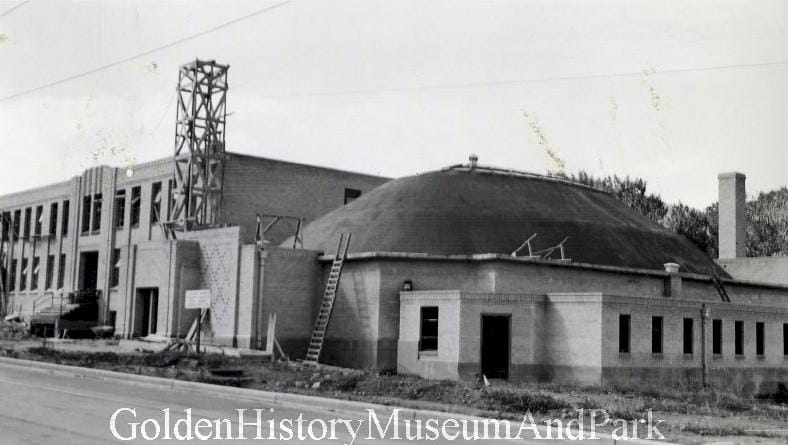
[0,0,788,207]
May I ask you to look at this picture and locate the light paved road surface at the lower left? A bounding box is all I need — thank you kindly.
[0,364,601,445]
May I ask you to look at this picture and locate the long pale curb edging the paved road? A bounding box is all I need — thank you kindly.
[0,357,674,445]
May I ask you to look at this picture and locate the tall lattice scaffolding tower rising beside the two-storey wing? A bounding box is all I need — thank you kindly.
[168,60,230,231]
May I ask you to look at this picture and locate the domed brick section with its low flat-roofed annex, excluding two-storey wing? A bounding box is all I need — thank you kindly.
[274,162,788,389]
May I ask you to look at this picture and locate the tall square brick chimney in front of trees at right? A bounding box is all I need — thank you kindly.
[717,172,747,259]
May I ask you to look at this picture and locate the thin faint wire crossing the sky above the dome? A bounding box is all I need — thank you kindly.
[262,60,788,99]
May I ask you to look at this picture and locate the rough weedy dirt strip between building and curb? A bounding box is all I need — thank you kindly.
[0,338,788,444]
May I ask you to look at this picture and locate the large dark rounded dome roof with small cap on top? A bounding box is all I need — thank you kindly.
[292,166,728,277]
